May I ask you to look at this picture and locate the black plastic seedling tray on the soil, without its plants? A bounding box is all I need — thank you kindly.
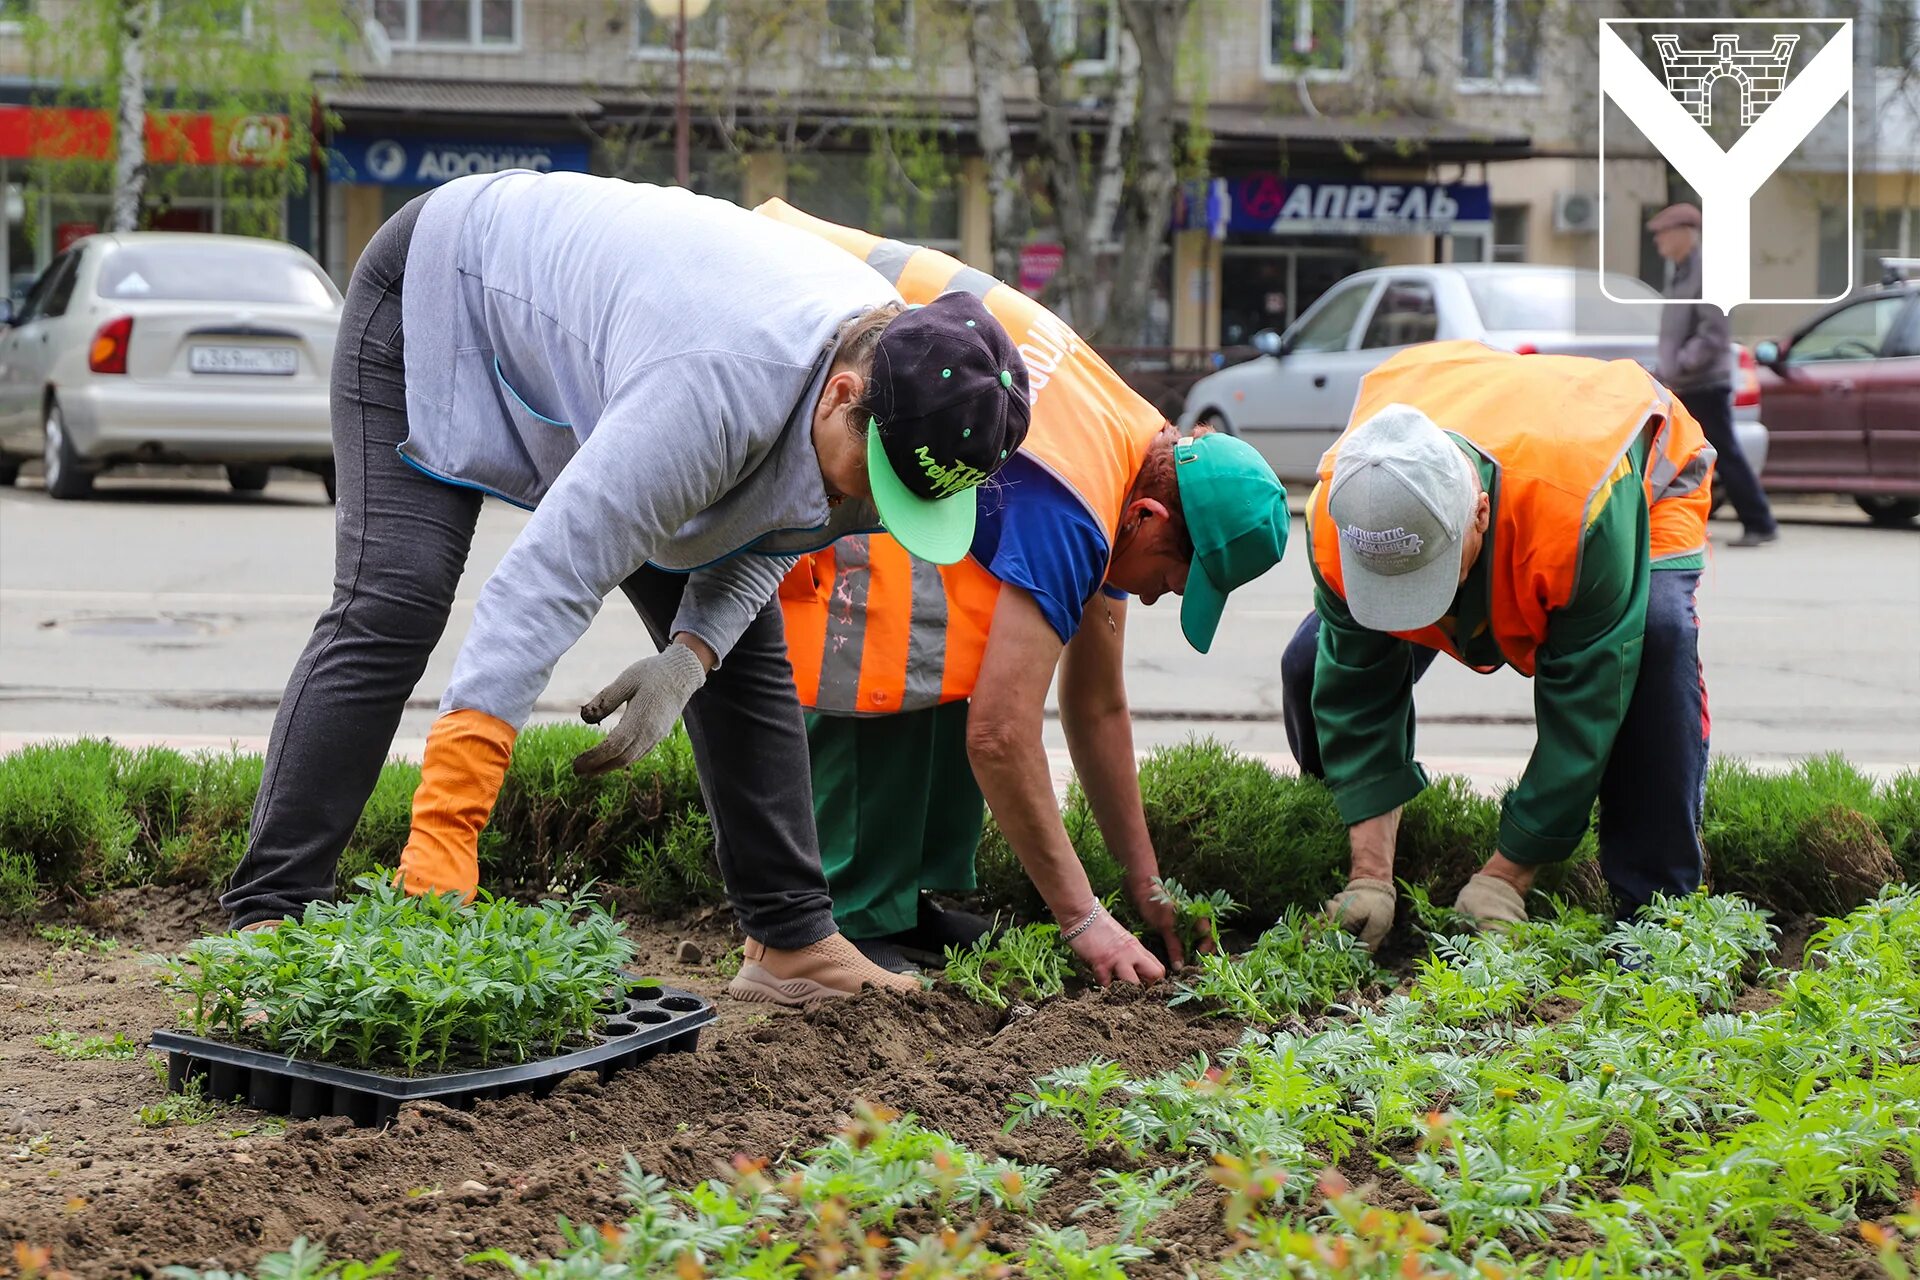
[154,975,718,1126]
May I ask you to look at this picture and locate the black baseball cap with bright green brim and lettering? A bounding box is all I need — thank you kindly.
[866,294,1029,564]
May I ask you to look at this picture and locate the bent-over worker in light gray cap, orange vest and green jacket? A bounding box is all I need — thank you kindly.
[1281,342,1715,946]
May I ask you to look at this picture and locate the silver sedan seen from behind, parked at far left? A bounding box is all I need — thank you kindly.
[0,232,340,499]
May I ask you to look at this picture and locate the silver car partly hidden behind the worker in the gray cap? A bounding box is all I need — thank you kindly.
[1181,263,1766,484]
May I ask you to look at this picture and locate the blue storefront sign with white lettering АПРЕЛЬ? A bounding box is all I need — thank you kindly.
[1173,173,1494,238]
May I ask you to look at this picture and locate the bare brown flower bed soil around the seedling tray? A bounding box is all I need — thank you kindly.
[0,890,1882,1280]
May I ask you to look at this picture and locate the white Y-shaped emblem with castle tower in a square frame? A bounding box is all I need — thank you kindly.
[1599,17,1853,311]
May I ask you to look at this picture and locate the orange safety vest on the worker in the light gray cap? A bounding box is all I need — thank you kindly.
[1308,342,1715,676]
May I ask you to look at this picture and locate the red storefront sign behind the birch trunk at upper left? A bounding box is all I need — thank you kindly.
[0,106,288,165]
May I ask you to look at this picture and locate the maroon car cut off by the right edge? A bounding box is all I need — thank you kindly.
[1753,272,1920,526]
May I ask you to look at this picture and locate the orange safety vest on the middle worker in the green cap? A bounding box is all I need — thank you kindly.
[756,200,1167,716]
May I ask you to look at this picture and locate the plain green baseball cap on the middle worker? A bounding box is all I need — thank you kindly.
[1173,432,1292,652]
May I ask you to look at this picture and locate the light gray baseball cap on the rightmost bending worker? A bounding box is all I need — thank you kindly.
[1327,405,1480,631]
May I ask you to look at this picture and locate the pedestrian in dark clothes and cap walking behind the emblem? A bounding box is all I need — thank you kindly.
[1647,203,1780,547]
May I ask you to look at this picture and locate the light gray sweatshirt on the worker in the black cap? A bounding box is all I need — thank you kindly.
[399,171,899,729]
